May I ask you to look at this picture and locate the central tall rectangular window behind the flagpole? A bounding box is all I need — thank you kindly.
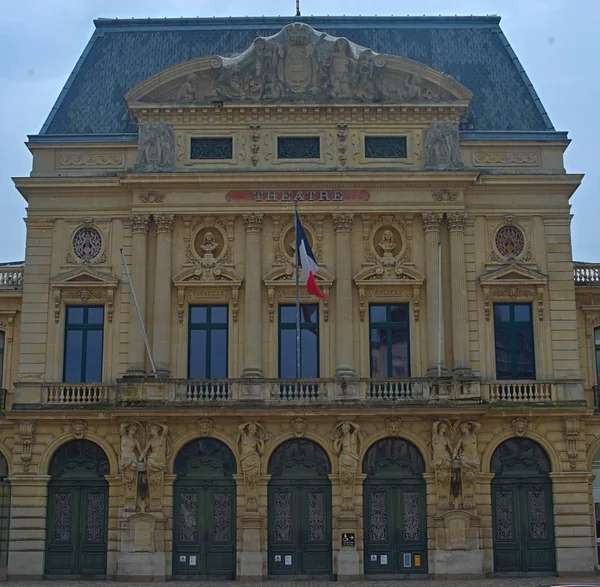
[279,304,319,379]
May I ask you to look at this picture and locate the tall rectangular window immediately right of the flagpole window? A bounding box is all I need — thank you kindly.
[369,304,410,378]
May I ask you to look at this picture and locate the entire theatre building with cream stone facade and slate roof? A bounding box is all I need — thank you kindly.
[0,17,600,580]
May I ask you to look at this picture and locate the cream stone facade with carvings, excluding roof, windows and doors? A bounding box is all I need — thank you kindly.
[0,17,600,580]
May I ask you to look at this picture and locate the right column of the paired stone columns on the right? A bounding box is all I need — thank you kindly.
[446,212,471,376]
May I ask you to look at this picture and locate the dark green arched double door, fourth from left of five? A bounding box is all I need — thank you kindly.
[362,438,427,575]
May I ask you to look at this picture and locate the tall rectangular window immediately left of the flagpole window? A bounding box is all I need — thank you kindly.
[188,306,228,379]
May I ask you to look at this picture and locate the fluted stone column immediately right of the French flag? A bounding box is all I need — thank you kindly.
[333,214,356,377]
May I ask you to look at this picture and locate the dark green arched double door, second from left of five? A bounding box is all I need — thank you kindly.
[173,438,236,579]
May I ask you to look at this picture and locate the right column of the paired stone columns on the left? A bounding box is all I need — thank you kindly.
[152,214,174,375]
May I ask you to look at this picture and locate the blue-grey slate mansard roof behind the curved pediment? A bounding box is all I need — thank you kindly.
[41,16,554,138]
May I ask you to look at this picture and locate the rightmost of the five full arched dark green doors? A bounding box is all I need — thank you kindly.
[490,437,556,573]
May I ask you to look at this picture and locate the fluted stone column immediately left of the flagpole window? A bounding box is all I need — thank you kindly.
[242,214,263,377]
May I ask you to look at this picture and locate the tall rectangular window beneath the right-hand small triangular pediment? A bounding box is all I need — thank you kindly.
[494,304,535,379]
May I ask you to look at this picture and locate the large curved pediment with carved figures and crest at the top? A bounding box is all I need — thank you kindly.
[125,23,472,109]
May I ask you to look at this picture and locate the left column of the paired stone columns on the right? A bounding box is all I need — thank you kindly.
[422,212,444,375]
